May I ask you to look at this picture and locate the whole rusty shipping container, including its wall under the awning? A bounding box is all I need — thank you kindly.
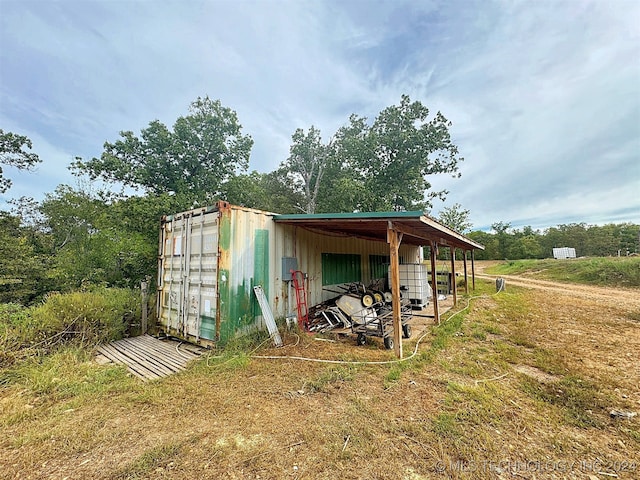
[157,202,421,344]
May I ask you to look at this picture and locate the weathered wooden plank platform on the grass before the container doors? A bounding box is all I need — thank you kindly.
[97,335,205,381]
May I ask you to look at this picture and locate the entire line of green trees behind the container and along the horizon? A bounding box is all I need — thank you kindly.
[0,95,637,304]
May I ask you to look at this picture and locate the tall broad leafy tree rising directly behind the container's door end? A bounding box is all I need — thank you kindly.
[72,97,253,203]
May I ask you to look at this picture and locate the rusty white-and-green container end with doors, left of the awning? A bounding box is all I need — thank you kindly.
[158,202,276,343]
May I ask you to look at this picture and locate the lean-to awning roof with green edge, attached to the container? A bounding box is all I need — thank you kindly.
[273,211,484,250]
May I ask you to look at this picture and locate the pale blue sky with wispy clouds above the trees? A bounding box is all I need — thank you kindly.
[0,0,640,229]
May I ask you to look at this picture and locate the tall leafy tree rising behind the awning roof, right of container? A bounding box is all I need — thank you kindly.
[335,95,462,211]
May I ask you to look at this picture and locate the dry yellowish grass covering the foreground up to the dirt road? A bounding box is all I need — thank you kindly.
[0,283,640,479]
